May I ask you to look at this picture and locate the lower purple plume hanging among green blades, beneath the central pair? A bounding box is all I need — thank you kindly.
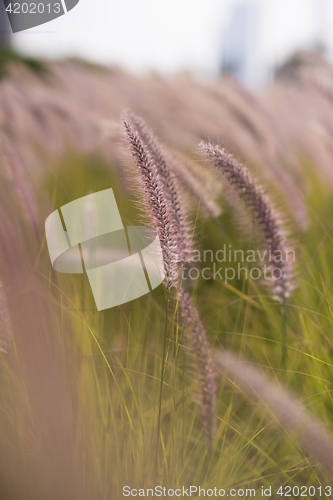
[179,289,217,452]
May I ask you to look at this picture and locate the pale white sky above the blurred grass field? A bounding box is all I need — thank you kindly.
[9,0,333,82]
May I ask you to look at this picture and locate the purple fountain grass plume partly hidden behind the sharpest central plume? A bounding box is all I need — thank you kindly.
[127,111,191,262]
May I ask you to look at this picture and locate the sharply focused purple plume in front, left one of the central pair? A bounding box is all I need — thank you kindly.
[124,120,181,292]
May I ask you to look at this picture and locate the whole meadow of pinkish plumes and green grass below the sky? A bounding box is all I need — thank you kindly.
[0,48,333,500]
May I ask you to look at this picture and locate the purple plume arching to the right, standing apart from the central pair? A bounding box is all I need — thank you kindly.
[200,142,293,304]
